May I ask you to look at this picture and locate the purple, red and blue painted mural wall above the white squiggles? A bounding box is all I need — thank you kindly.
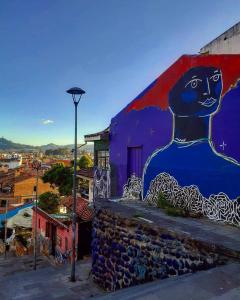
[110,55,240,209]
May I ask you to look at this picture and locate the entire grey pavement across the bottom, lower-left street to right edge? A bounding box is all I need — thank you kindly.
[0,257,240,300]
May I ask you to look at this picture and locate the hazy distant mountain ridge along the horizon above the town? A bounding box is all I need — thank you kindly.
[0,137,93,152]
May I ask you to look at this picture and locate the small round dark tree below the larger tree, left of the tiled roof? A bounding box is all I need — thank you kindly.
[38,192,59,214]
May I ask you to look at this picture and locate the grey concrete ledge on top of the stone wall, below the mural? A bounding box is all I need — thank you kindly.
[95,199,240,258]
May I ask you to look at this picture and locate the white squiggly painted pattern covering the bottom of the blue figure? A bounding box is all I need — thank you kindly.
[144,172,240,226]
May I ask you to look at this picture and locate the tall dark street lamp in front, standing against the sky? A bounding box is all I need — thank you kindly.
[67,87,85,282]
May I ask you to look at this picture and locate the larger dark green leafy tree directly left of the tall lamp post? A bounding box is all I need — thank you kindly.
[42,164,73,195]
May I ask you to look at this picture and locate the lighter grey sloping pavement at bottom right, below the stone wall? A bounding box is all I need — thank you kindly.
[94,264,240,300]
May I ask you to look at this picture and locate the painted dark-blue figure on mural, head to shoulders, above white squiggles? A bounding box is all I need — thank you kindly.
[143,67,240,199]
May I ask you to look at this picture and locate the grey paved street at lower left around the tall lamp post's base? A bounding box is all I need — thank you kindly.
[0,256,104,300]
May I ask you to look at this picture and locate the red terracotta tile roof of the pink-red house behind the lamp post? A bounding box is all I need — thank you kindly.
[62,196,93,221]
